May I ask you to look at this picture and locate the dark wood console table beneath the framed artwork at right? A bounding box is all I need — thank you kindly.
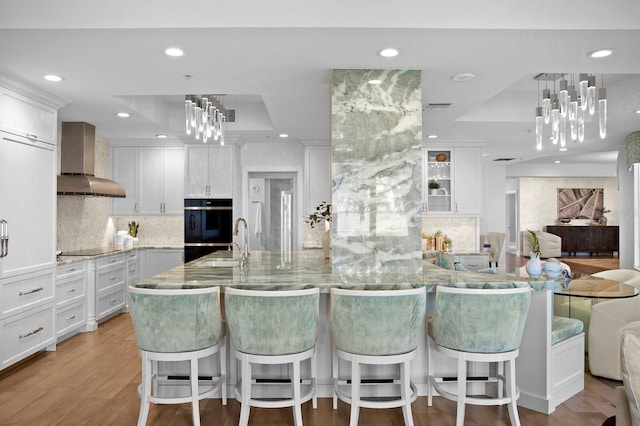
[547,225,619,255]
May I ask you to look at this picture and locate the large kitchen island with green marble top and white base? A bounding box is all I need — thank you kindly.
[136,250,584,413]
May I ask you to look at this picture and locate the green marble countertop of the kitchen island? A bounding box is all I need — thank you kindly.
[136,249,558,291]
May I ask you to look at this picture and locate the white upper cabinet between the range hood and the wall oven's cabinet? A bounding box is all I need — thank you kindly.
[112,146,184,216]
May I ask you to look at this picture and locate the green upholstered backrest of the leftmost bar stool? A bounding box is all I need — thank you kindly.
[129,287,225,353]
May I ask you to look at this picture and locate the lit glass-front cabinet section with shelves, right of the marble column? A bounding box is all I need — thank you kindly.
[423,148,453,213]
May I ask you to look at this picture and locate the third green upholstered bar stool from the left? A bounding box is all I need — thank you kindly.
[331,287,427,426]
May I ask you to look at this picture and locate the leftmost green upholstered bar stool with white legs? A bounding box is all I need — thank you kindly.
[129,287,227,426]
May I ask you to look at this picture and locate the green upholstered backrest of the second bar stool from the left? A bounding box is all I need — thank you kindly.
[224,288,320,355]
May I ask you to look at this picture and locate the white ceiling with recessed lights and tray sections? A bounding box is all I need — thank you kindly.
[0,0,640,163]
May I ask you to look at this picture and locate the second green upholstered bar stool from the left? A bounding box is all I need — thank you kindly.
[224,288,320,426]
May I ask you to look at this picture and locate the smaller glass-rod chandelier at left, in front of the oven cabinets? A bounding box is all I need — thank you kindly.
[184,95,226,145]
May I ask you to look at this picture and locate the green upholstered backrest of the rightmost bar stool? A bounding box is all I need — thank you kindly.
[429,286,531,353]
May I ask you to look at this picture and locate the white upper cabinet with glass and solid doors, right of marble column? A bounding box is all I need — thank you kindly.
[423,148,482,216]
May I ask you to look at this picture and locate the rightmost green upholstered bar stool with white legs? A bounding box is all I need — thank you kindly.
[427,283,531,426]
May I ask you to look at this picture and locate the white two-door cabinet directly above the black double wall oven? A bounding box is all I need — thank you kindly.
[184,144,234,198]
